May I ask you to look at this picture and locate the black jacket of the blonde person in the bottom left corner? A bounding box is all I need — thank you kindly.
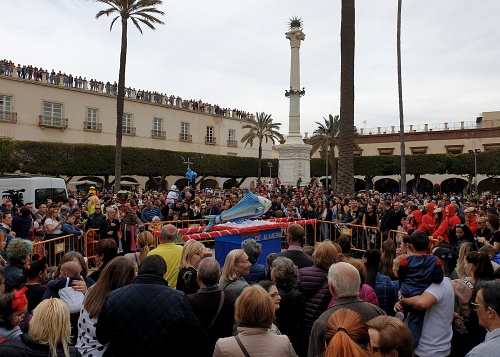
[0,333,81,357]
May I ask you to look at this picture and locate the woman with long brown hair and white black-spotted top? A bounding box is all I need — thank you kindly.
[76,257,136,357]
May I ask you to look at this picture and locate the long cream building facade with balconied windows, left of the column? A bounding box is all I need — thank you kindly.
[0,73,273,187]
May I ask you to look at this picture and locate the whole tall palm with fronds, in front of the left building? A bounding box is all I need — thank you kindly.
[94,0,164,191]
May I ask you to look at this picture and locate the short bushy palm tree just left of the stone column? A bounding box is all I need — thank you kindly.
[241,112,284,185]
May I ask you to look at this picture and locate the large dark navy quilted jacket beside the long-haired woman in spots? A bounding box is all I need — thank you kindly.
[96,274,203,357]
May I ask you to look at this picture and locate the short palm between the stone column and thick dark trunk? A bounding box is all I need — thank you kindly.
[309,114,340,191]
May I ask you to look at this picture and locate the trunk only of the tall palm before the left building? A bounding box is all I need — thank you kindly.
[115,18,127,192]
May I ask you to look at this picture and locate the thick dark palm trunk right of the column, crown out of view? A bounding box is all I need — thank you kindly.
[338,0,355,193]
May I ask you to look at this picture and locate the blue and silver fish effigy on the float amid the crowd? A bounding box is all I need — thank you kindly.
[203,189,271,232]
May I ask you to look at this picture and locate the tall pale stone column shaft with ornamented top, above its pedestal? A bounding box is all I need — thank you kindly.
[285,17,306,144]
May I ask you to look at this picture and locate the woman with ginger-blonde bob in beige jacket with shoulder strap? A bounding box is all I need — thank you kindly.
[214,284,292,357]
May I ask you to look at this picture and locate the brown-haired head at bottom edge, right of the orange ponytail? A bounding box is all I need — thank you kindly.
[367,316,413,357]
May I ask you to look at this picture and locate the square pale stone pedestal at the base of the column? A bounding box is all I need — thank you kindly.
[277,143,312,186]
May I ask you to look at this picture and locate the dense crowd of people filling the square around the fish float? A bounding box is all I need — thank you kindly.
[0,183,500,357]
